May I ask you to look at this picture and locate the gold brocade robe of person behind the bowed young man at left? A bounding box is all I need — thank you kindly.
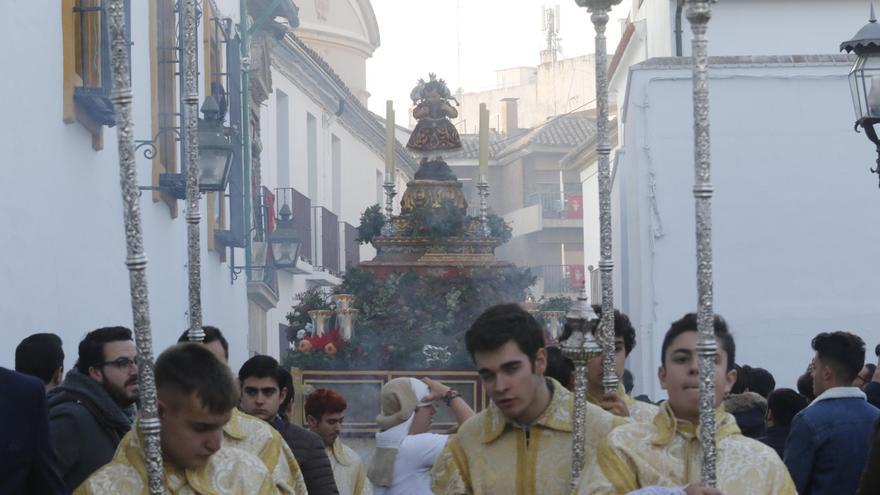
[223,408,308,495]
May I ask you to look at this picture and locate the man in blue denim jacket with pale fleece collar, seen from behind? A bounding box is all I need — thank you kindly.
[785,332,880,495]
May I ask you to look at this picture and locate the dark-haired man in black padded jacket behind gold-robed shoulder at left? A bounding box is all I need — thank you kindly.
[238,356,339,495]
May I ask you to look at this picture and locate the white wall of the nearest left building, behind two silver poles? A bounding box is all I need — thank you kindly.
[0,2,247,369]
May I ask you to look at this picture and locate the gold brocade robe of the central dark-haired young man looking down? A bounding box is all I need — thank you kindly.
[431,379,625,495]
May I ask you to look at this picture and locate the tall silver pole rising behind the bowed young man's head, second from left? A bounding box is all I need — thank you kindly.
[181,0,205,342]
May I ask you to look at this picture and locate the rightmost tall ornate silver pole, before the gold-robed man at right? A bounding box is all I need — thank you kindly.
[687,0,717,487]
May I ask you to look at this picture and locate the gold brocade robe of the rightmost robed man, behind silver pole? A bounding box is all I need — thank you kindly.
[576,403,797,495]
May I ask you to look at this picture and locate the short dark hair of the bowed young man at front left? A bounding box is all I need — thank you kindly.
[155,342,238,414]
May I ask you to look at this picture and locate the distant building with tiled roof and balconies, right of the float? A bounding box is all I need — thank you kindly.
[444,113,596,298]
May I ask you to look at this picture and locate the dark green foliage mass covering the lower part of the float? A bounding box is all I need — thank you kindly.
[284,267,535,370]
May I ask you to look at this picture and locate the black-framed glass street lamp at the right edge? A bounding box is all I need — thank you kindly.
[840,4,880,187]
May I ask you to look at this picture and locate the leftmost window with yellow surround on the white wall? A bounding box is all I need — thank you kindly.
[61,0,131,150]
